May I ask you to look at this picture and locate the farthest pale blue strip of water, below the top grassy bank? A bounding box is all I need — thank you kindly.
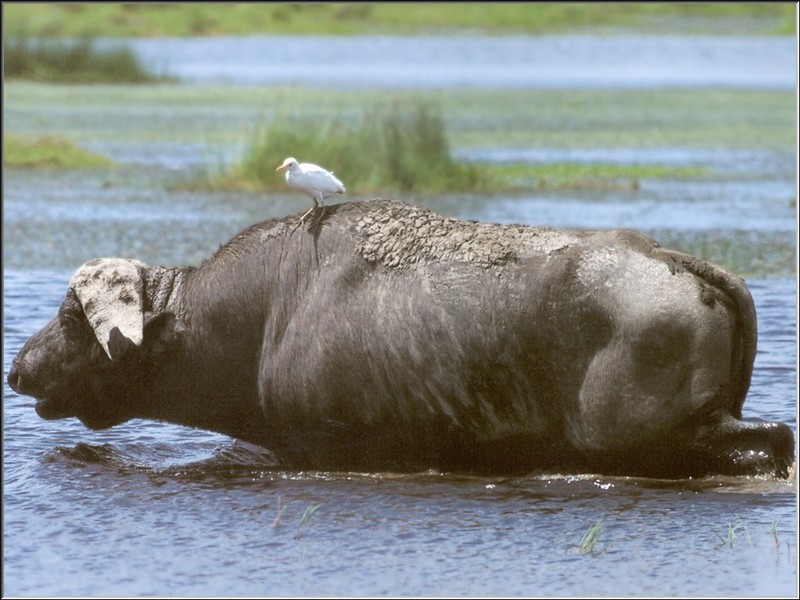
[122,35,797,89]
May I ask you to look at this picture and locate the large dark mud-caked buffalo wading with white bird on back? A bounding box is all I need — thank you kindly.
[8,199,794,477]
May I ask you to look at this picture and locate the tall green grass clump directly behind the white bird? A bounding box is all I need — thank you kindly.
[212,103,485,193]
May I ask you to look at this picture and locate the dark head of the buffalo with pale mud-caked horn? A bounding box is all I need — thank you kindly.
[8,259,180,429]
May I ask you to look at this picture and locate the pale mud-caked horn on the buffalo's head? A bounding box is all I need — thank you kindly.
[69,258,145,360]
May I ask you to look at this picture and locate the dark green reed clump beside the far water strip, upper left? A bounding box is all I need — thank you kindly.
[3,36,166,83]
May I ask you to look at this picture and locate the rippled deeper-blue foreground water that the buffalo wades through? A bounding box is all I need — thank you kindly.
[3,270,797,597]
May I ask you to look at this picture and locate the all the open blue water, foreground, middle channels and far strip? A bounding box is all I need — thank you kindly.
[3,37,797,597]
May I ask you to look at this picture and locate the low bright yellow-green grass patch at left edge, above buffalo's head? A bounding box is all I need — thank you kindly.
[3,136,113,169]
